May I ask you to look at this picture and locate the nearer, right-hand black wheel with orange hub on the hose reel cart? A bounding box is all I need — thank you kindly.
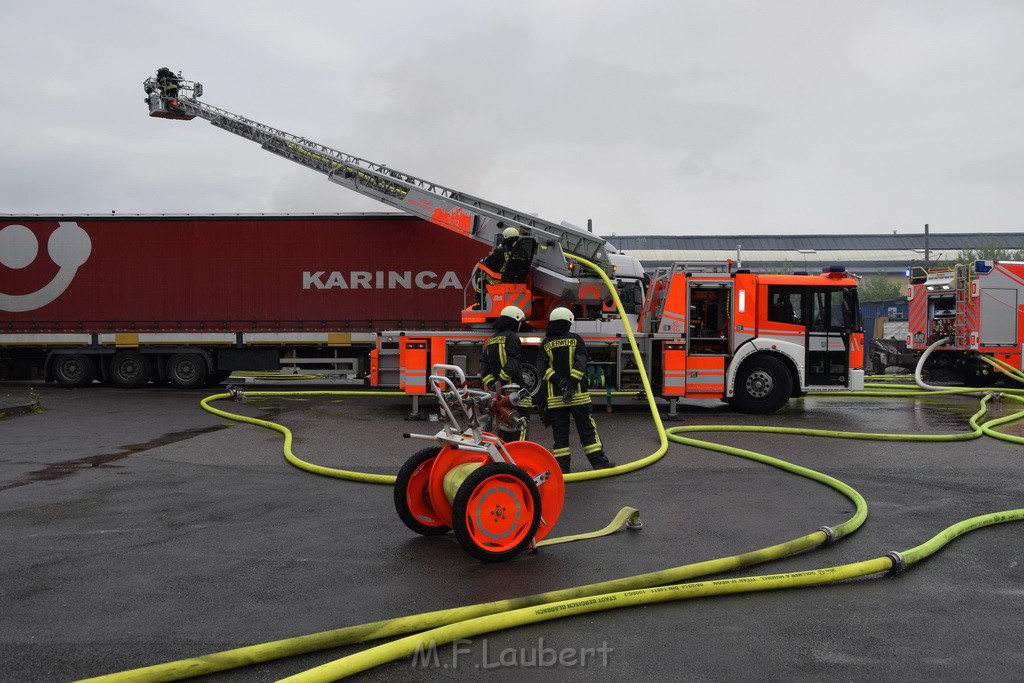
[452,463,541,562]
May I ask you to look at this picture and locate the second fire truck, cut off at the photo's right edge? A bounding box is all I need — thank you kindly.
[906,261,1024,386]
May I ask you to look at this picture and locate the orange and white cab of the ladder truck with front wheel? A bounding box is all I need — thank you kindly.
[639,261,863,413]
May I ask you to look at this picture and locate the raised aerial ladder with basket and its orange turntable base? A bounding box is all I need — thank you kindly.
[143,68,614,324]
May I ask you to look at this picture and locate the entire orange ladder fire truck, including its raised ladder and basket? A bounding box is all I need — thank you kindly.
[143,77,864,415]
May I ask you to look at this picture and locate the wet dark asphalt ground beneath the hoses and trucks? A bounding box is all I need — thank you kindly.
[0,384,1024,682]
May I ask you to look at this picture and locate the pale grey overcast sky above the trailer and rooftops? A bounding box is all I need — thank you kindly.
[0,0,1024,234]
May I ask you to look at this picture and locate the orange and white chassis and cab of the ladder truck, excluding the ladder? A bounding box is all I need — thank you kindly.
[372,261,863,413]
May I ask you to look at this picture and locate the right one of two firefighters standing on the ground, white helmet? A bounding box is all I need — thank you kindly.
[537,306,615,472]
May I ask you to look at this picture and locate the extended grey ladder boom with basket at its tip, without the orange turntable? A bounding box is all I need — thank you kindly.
[143,73,612,301]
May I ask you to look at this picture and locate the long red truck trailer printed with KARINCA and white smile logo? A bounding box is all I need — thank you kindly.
[0,214,487,387]
